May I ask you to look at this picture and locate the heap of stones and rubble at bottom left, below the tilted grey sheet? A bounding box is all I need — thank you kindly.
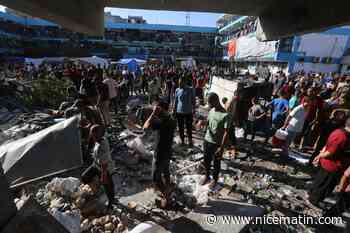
[35,177,126,233]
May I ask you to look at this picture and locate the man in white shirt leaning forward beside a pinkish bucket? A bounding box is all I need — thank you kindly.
[282,97,309,149]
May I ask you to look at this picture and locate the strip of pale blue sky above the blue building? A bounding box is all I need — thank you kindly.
[0,5,223,27]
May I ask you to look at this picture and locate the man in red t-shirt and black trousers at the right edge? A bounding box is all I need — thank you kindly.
[309,118,350,206]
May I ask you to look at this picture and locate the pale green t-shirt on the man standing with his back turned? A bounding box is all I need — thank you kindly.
[204,109,230,145]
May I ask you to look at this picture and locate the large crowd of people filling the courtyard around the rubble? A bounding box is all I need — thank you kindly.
[4,61,350,216]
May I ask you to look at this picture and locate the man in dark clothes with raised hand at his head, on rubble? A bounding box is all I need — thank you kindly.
[143,100,176,194]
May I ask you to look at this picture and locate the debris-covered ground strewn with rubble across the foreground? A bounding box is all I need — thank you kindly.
[1,92,346,233]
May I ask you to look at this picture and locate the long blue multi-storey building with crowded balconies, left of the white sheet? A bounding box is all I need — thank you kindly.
[0,12,220,63]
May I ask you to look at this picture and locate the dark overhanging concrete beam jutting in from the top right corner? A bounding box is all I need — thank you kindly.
[257,0,350,41]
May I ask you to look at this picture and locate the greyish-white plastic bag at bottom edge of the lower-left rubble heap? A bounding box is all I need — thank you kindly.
[51,209,81,233]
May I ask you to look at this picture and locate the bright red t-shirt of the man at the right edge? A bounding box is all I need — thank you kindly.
[320,129,350,172]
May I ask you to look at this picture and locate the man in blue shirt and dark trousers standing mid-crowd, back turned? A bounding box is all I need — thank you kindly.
[174,79,196,146]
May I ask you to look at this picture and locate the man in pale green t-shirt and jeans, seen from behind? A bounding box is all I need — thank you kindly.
[202,93,230,187]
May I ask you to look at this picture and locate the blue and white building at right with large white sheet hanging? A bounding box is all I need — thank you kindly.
[218,16,350,73]
